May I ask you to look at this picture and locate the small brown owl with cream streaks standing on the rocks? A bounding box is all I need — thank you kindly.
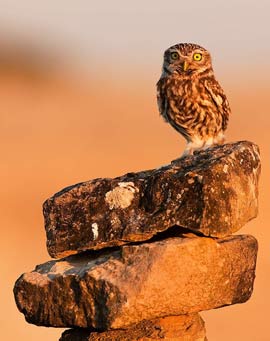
[157,43,231,155]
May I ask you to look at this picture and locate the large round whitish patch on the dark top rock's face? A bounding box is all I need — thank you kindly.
[105,182,139,210]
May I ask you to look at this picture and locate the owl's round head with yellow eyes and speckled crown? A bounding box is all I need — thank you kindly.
[162,43,212,75]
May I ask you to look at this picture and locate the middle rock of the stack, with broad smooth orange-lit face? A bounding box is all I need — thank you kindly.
[14,234,257,330]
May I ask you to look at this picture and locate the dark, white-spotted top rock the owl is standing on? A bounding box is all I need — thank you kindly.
[44,141,260,258]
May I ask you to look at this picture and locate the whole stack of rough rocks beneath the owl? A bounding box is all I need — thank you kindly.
[14,141,260,341]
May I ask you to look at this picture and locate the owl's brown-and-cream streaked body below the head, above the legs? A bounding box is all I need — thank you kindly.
[157,75,228,144]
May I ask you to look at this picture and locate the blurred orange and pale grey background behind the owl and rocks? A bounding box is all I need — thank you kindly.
[0,0,270,341]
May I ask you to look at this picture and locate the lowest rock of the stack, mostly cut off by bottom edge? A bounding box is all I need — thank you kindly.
[59,314,207,341]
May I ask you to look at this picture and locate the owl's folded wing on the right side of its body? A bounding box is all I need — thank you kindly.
[204,79,231,131]
